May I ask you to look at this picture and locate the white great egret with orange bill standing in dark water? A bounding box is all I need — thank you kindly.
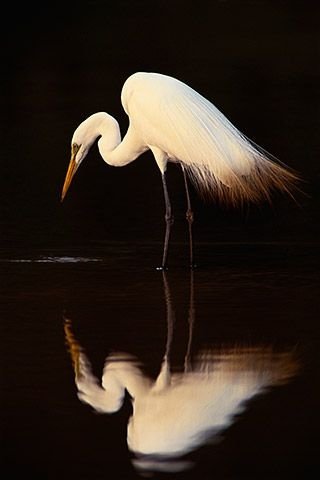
[61,72,297,269]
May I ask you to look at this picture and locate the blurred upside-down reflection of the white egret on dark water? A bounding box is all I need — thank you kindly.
[65,274,296,470]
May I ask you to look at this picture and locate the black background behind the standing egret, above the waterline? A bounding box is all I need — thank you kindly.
[0,0,320,253]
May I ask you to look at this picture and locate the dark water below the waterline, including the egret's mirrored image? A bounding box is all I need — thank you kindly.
[0,249,320,480]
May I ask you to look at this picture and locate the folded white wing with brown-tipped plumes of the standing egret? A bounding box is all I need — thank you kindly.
[126,74,295,202]
